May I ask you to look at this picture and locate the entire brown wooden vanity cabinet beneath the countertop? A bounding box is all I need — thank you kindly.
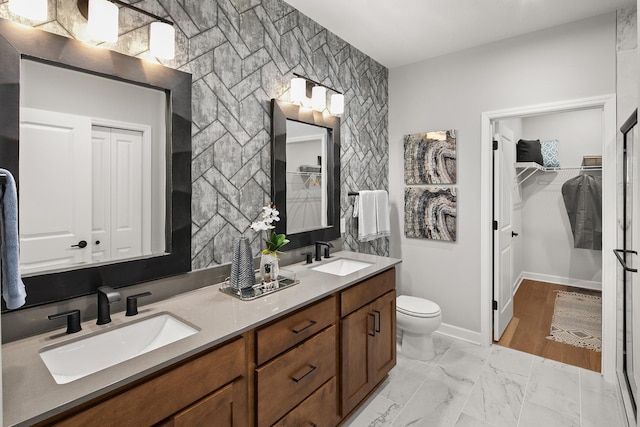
[39,268,396,427]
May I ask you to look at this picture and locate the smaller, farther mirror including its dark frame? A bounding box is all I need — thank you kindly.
[271,100,340,249]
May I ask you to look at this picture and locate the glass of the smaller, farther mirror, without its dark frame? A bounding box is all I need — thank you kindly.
[286,120,327,234]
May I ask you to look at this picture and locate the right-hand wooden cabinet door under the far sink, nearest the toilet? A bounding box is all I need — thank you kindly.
[370,291,396,385]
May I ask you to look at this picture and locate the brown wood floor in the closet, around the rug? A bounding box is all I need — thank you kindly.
[496,280,602,372]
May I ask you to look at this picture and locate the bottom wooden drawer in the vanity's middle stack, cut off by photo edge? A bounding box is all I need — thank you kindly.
[274,377,338,427]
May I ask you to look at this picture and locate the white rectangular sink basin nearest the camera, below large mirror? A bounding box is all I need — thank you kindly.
[40,313,198,384]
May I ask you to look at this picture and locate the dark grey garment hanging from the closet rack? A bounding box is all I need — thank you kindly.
[562,173,602,250]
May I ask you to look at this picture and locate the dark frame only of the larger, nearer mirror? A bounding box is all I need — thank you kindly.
[0,19,191,311]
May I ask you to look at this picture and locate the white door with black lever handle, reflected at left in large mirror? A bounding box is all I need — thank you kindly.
[19,108,91,274]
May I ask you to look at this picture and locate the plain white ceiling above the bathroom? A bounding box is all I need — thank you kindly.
[285,0,636,68]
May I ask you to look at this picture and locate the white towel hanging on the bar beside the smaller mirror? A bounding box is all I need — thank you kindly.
[354,190,391,242]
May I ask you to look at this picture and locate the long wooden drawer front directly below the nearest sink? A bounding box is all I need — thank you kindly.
[55,338,247,427]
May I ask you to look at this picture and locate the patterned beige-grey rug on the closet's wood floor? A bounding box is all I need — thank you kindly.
[547,291,602,352]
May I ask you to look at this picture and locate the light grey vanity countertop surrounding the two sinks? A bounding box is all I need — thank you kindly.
[2,251,401,426]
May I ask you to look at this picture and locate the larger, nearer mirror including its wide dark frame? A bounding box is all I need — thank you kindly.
[0,20,191,310]
